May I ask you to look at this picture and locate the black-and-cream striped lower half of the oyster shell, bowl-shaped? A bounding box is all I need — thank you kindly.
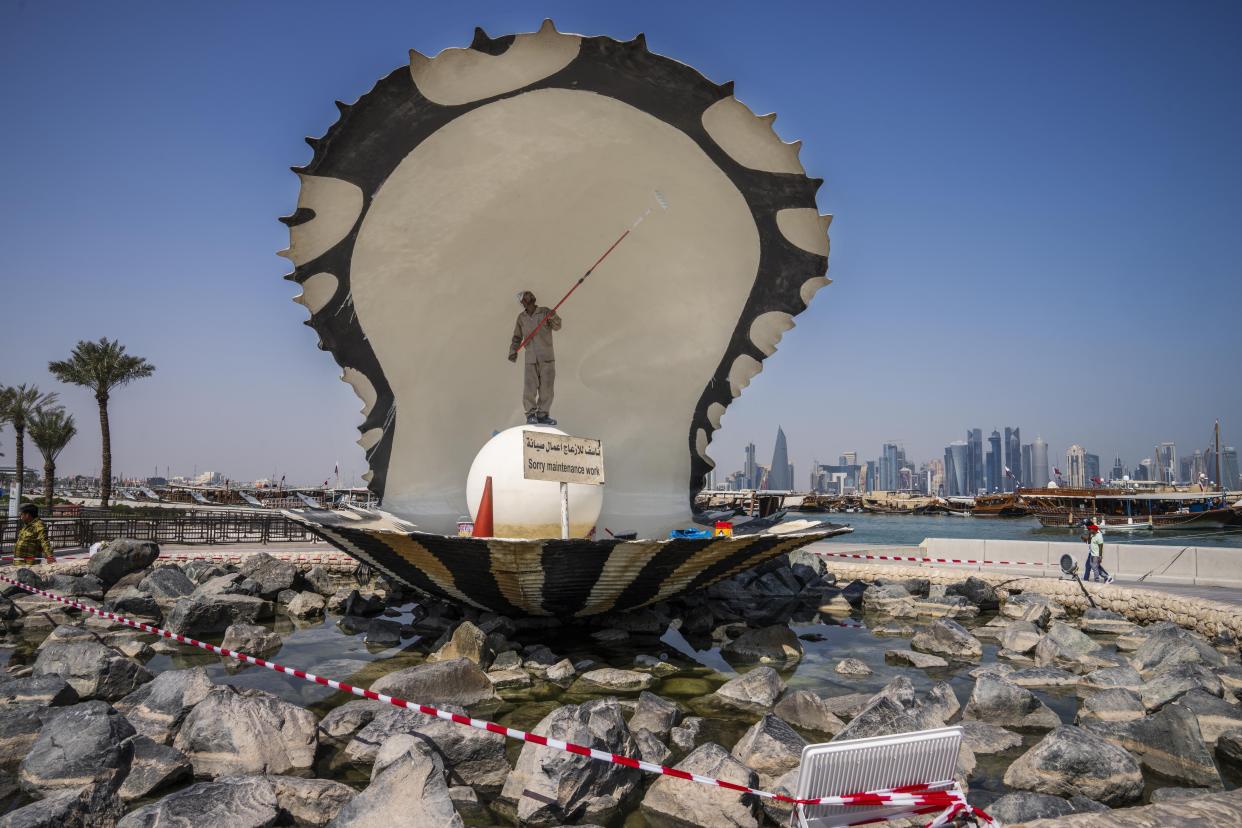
[284,509,852,619]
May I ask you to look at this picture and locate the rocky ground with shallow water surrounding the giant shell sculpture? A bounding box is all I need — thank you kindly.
[0,541,1242,828]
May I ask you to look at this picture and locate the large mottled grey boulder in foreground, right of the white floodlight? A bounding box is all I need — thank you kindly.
[1005,725,1143,807]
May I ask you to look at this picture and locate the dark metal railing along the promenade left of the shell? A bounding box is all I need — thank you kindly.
[0,511,318,551]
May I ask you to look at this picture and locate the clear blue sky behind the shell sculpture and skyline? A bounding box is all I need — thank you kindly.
[0,0,1242,482]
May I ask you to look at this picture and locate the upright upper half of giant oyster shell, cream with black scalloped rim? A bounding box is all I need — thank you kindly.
[282,21,830,547]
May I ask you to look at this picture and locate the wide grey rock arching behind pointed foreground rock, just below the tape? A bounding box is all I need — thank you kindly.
[342,705,509,797]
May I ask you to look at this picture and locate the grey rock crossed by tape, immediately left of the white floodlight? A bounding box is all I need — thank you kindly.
[642,742,760,828]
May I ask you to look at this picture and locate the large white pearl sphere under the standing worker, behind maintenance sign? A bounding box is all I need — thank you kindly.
[466,426,604,538]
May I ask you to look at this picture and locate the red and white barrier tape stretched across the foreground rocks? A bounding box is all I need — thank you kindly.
[0,575,994,828]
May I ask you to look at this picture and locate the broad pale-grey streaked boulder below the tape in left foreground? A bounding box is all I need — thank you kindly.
[173,684,319,777]
